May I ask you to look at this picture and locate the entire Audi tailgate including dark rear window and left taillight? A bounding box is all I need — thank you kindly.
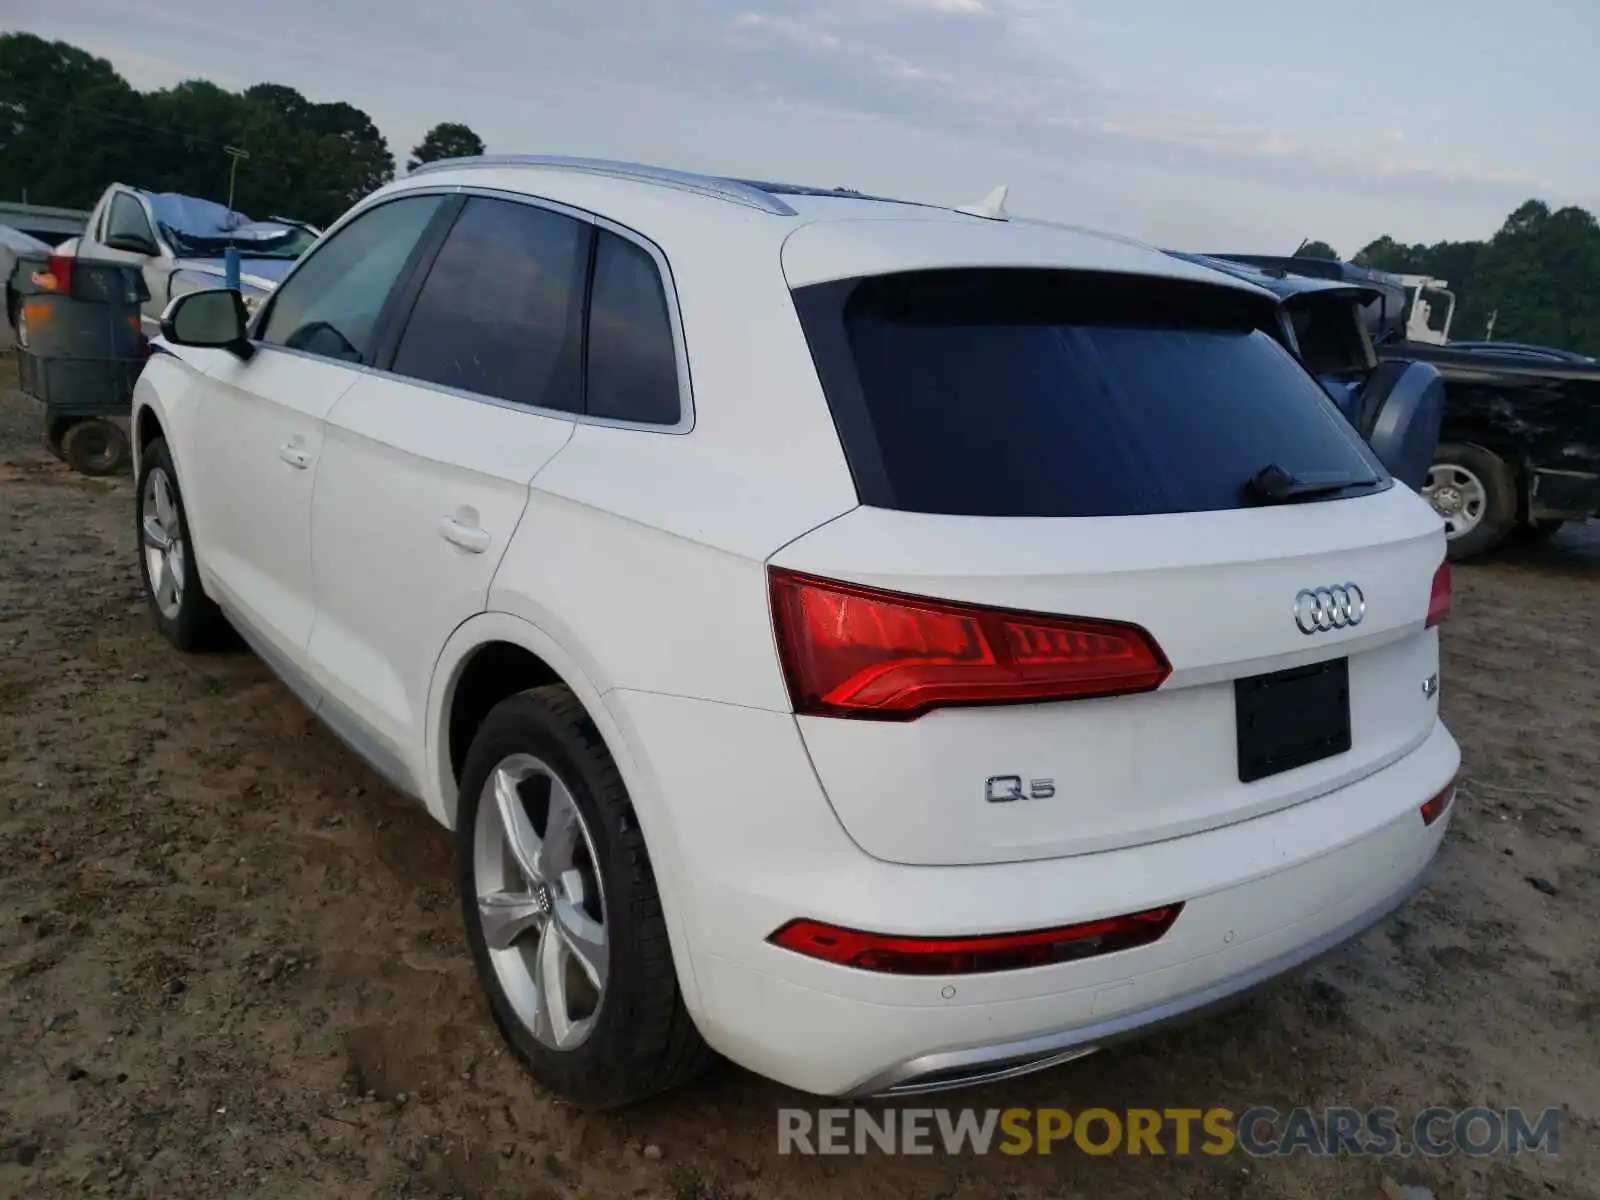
[773,270,1443,864]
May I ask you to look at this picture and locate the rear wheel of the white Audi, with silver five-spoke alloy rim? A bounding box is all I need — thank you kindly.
[456,685,715,1109]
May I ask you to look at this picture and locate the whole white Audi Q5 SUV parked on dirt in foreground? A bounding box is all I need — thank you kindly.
[133,157,1459,1106]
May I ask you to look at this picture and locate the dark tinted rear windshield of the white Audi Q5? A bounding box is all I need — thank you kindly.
[794,269,1390,517]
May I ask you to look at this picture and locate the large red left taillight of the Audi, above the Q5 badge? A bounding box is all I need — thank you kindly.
[771,568,1171,720]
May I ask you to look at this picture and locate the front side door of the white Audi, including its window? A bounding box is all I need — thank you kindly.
[182,195,443,664]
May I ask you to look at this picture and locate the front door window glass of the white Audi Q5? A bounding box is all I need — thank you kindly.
[261,195,443,363]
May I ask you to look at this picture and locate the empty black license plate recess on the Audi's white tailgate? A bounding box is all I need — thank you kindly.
[1234,658,1350,784]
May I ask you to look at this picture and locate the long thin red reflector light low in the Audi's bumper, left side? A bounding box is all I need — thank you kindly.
[768,904,1184,974]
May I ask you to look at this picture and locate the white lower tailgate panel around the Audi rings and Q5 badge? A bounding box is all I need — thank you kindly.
[773,488,1440,866]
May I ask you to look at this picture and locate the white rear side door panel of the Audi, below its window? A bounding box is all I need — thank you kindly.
[306,373,573,790]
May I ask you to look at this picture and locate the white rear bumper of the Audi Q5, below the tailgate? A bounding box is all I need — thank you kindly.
[606,693,1461,1094]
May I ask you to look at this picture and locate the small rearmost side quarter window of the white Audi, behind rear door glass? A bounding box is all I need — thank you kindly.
[587,229,682,426]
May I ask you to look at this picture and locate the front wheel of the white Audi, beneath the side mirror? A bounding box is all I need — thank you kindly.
[133,438,227,651]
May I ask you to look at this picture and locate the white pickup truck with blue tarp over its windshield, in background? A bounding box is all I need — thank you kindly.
[58,184,320,336]
